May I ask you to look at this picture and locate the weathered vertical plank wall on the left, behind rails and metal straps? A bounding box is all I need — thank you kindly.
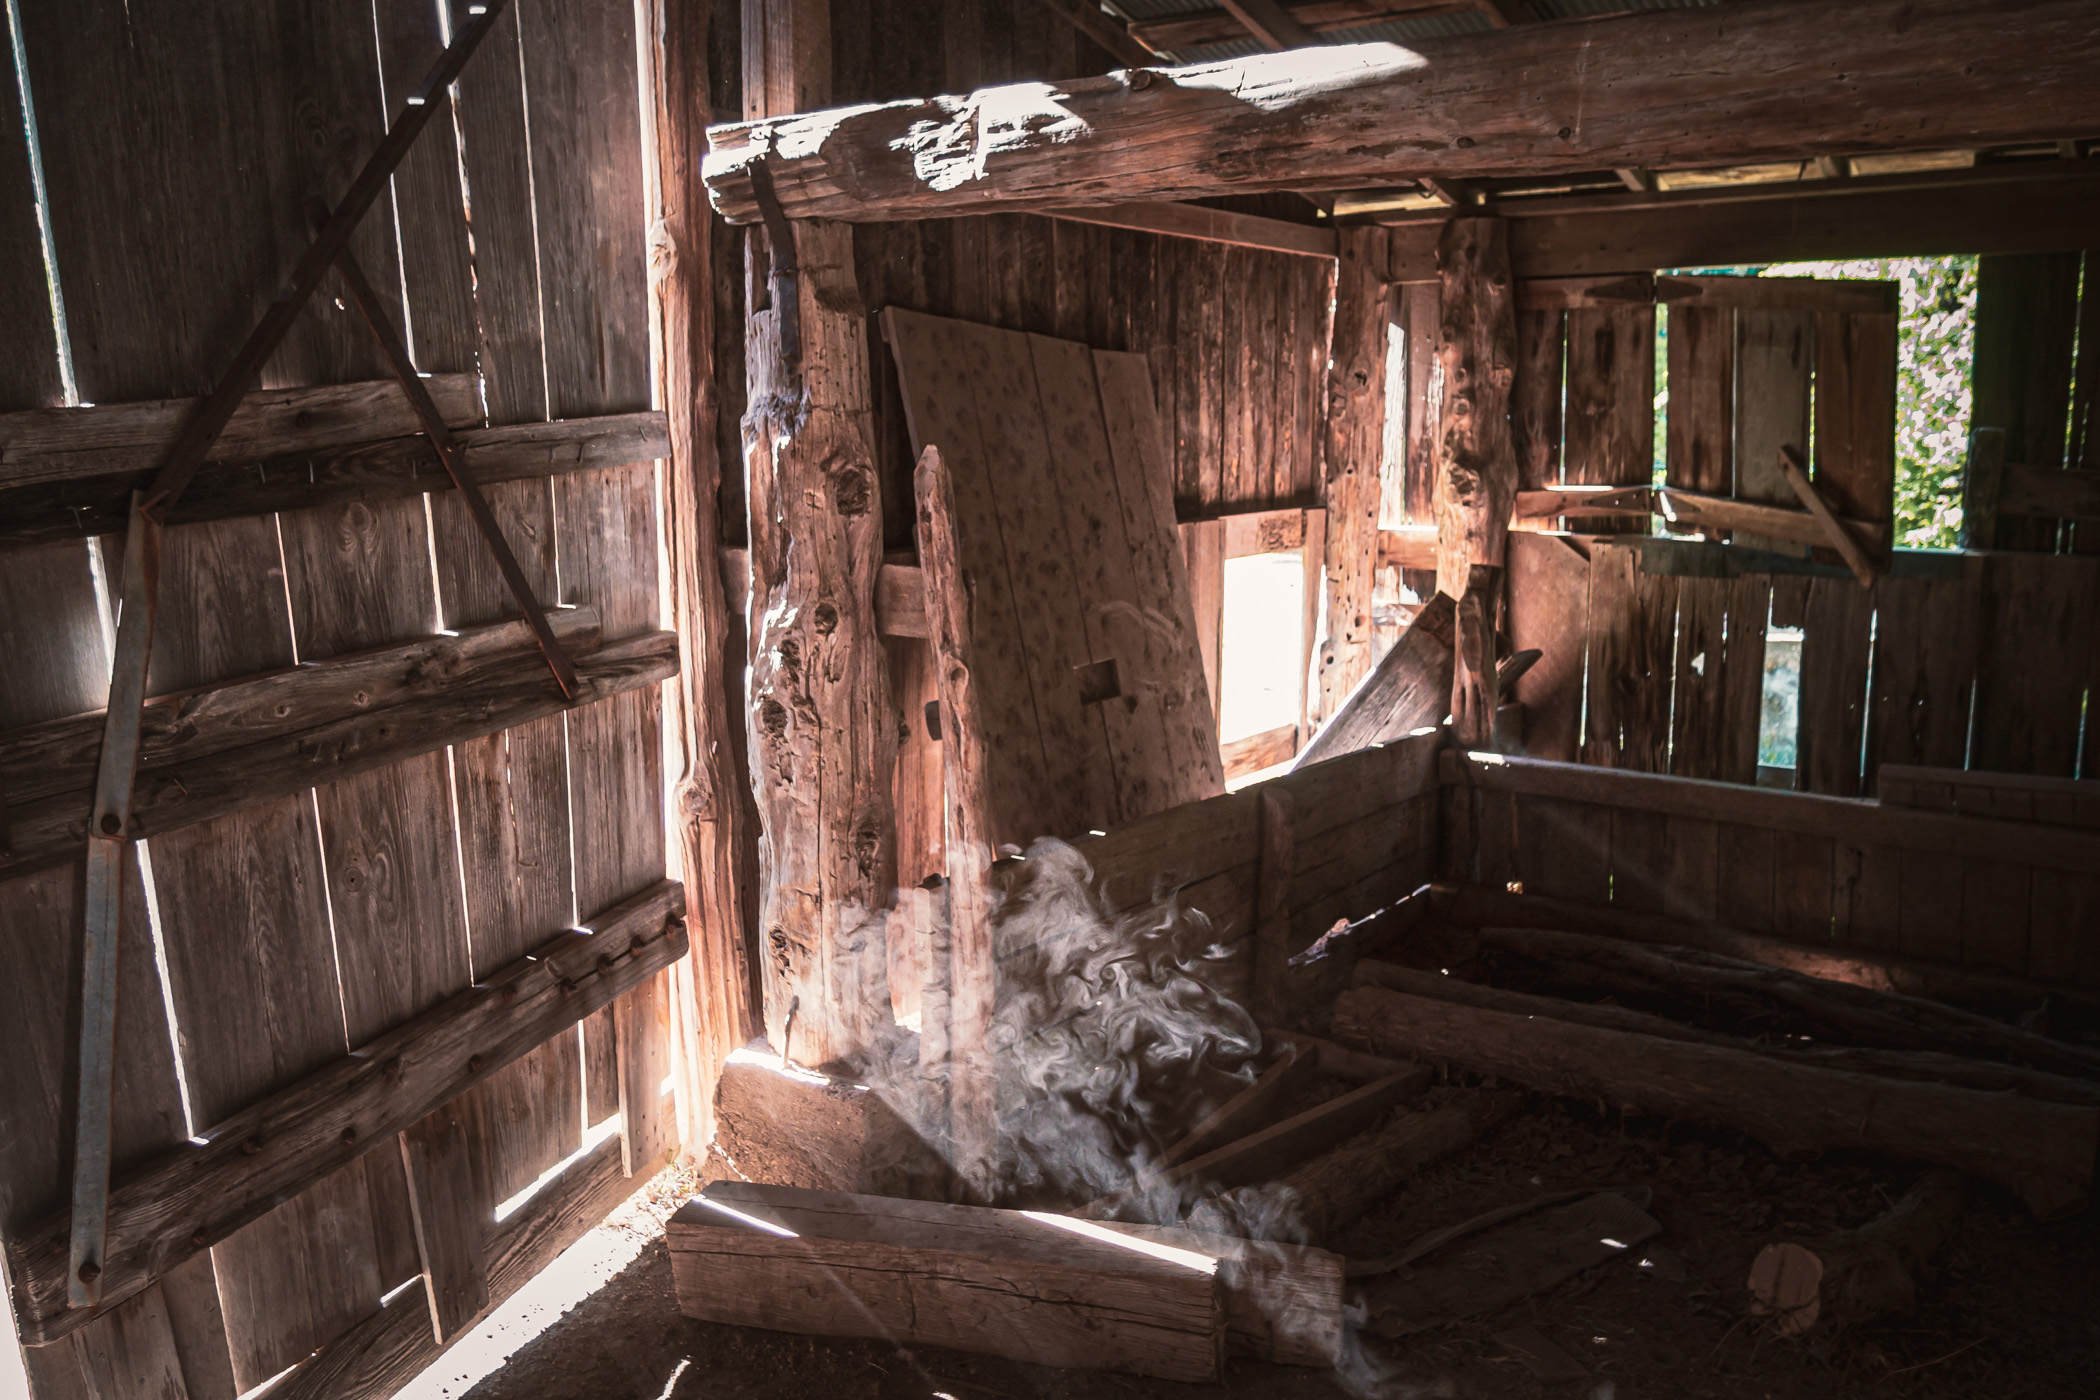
[0,0,676,1400]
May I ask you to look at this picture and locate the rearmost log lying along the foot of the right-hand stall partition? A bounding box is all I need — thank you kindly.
[1432,886,2100,1020]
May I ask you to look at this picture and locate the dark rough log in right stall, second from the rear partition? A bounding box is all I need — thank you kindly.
[1481,928,2100,1079]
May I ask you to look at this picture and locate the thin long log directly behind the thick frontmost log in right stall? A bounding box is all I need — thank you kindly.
[1357,961,2100,1104]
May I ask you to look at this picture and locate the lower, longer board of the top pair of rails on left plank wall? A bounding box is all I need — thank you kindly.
[0,413,670,546]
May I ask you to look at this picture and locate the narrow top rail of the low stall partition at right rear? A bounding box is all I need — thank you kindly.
[1441,751,2100,875]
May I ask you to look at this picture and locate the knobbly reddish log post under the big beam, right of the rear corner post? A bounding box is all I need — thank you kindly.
[1436,218,1516,749]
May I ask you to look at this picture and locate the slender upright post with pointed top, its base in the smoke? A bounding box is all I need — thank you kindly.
[914,447,1000,1196]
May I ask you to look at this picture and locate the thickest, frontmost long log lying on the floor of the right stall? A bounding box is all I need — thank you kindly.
[1334,987,2100,1219]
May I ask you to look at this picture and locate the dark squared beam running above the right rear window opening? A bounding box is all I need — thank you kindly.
[1378,162,2100,281]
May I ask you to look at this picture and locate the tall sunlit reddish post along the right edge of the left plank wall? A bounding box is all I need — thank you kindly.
[643,0,754,1150]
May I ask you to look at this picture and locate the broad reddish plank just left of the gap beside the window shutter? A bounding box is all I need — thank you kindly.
[1562,306,1655,535]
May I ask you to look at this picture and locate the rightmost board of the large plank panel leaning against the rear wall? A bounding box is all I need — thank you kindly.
[1092,353,1226,802]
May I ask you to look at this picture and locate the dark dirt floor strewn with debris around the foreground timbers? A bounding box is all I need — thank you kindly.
[447,1096,2100,1400]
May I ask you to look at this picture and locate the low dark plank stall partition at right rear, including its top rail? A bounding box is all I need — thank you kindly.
[1443,754,2100,987]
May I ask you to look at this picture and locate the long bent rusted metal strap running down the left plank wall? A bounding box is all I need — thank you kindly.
[67,0,508,1308]
